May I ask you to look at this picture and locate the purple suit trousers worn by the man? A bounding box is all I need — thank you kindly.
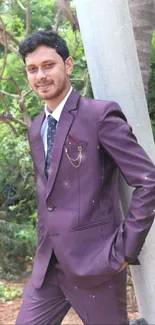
[16,256,129,325]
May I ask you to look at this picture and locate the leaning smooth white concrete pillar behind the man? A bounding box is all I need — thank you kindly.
[75,0,155,318]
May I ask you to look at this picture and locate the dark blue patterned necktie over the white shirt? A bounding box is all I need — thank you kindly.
[45,115,57,177]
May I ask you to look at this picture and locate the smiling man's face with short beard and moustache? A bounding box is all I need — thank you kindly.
[25,45,73,100]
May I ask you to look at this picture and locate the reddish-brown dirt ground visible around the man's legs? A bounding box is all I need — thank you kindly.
[0,280,139,325]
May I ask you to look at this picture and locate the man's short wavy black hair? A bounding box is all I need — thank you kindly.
[19,30,69,63]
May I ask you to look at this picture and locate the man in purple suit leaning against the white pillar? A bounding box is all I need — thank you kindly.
[16,31,155,325]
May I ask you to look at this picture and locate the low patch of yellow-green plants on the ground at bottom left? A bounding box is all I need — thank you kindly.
[0,282,22,302]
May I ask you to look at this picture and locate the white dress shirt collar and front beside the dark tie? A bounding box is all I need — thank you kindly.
[40,87,73,157]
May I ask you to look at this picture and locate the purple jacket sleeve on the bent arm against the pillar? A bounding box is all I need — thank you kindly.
[98,102,155,260]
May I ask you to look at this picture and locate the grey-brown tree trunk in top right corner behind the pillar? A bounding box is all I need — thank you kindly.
[128,0,154,95]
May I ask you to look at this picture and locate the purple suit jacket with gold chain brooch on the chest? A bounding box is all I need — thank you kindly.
[29,90,155,288]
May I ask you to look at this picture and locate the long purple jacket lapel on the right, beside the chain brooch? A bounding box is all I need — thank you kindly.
[46,90,80,199]
